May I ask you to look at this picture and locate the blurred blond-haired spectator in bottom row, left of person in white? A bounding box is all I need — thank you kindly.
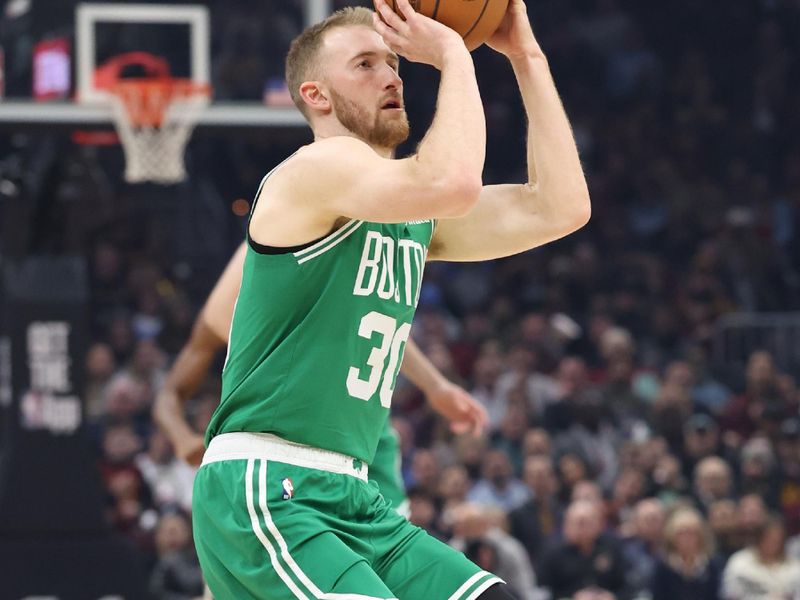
[650,508,722,600]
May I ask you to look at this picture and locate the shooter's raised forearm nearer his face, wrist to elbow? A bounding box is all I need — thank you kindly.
[416,46,486,201]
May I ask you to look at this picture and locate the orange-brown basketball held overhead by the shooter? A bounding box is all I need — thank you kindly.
[389,0,508,51]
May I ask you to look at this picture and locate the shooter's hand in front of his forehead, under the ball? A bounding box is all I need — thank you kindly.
[373,0,468,70]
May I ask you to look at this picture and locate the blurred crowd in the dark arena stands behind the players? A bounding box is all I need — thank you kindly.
[0,0,800,600]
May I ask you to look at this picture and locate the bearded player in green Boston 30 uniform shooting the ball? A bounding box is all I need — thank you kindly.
[193,0,589,600]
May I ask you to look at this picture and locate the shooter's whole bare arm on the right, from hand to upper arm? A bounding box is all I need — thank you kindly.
[428,0,591,261]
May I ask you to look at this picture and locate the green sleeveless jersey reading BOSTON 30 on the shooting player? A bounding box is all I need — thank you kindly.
[206,164,434,463]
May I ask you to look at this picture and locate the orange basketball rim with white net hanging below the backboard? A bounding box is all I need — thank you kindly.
[106,76,211,184]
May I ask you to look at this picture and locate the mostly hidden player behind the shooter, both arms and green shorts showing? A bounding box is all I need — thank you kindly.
[153,244,488,516]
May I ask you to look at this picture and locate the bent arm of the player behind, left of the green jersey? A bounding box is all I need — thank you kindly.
[153,244,246,465]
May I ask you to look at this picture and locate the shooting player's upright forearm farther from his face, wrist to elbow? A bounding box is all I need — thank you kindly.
[511,51,591,226]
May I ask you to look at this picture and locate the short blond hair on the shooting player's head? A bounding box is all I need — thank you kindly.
[286,6,372,119]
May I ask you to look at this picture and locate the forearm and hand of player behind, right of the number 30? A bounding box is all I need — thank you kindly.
[400,340,489,435]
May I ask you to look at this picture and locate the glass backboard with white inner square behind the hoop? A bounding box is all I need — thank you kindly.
[0,0,333,130]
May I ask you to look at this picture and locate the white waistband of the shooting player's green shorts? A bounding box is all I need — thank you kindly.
[203,431,369,481]
